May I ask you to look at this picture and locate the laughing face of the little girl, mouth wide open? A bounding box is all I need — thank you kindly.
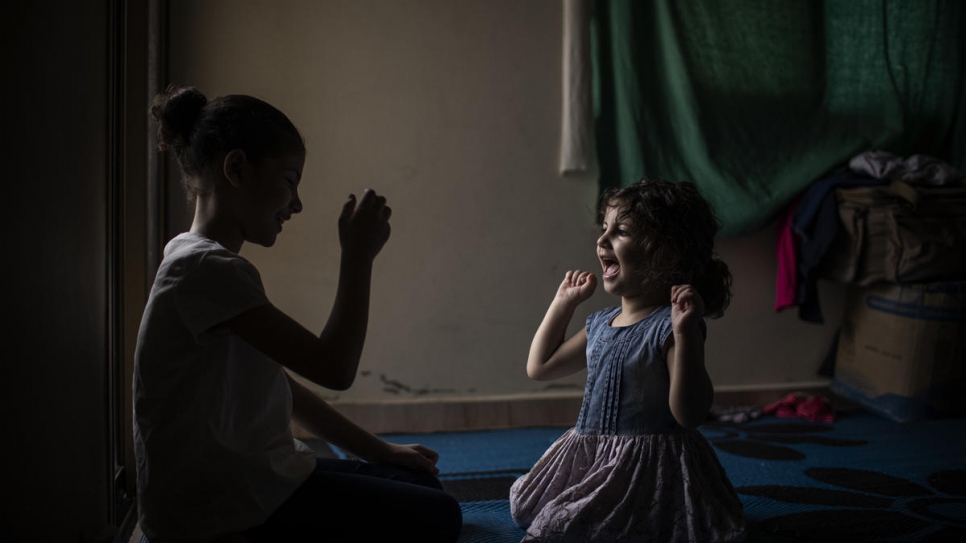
[597,205,645,297]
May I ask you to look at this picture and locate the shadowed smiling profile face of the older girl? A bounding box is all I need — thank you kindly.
[243,151,305,247]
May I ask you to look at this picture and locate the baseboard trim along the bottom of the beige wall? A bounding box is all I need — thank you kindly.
[304,381,830,438]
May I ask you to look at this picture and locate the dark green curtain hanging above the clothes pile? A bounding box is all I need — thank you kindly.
[591,0,966,236]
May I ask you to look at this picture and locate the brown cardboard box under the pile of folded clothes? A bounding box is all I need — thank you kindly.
[832,282,966,422]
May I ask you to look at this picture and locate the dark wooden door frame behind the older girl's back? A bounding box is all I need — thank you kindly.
[111,0,168,541]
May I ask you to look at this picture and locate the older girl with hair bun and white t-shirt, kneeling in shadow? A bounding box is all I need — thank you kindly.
[134,88,461,543]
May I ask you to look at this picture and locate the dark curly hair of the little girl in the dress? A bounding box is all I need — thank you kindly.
[598,179,731,318]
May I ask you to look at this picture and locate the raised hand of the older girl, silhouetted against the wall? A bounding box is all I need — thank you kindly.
[339,189,392,260]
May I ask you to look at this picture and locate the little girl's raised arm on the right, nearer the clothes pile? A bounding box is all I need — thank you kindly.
[667,285,714,428]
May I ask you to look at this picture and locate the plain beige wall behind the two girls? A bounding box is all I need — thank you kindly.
[170,0,841,412]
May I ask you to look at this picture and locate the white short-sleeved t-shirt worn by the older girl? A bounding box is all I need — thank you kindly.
[134,233,315,542]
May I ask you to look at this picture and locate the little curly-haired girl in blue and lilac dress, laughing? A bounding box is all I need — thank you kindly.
[510,180,744,542]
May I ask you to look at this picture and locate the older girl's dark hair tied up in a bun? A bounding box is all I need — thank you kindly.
[151,86,305,201]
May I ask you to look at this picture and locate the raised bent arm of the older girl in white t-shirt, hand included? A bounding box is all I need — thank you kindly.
[228,190,391,390]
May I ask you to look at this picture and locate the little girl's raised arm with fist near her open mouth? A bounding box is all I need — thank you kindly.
[527,270,597,381]
